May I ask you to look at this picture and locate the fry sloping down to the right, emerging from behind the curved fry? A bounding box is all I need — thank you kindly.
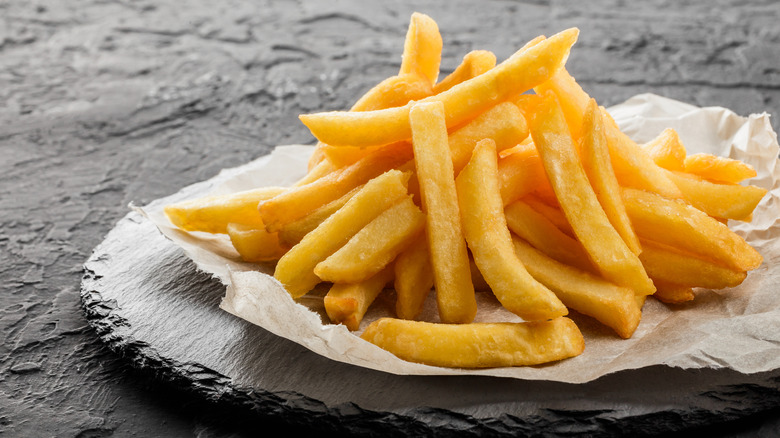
[513,237,642,339]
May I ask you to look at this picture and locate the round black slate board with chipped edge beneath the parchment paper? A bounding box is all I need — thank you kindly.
[81,207,780,436]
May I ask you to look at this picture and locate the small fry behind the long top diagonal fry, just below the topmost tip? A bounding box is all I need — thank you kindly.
[349,73,433,111]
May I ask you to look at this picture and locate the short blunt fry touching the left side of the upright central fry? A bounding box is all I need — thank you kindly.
[314,196,425,283]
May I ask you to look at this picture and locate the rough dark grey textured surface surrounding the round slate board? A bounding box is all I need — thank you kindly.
[0,0,780,437]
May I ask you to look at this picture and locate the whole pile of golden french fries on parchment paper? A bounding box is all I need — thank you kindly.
[165,13,766,368]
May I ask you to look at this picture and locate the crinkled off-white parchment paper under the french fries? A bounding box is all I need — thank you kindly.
[137,94,780,383]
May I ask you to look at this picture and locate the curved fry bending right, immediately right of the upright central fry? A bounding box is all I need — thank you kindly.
[455,139,568,321]
